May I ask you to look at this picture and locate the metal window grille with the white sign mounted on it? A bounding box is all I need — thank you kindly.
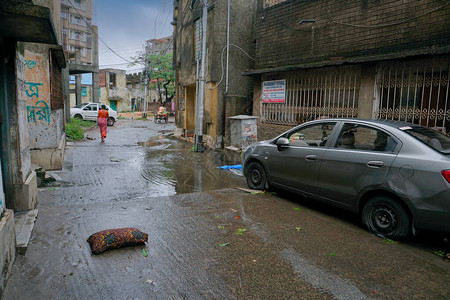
[260,66,361,125]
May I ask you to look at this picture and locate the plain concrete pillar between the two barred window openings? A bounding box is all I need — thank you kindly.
[358,64,376,119]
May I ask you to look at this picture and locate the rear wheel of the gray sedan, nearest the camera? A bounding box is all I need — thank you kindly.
[362,196,411,240]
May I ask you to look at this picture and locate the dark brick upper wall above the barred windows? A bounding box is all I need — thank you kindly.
[255,0,450,69]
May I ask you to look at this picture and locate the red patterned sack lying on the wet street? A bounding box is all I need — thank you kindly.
[87,228,148,254]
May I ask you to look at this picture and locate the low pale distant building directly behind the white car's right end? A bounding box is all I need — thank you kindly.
[99,69,132,112]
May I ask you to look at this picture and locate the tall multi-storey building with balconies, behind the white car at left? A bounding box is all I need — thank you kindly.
[60,0,99,108]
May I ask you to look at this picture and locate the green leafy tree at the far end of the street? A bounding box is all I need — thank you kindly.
[132,52,175,103]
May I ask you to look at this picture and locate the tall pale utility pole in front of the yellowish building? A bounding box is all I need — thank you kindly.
[195,0,208,152]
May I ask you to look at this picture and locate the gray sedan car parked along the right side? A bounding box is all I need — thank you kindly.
[243,119,450,239]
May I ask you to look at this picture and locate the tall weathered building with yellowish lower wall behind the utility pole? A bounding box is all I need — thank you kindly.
[172,0,257,148]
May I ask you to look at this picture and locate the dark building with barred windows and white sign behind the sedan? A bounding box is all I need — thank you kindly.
[245,0,450,139]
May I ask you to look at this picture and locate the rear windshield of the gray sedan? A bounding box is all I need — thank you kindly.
[400,126,450,154]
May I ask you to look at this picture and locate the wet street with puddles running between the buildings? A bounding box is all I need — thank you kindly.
[4,120,450,299]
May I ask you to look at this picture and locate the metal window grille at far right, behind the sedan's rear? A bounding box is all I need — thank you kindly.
[375,56,450,131]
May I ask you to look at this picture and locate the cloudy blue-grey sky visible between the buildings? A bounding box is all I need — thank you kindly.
[92,0,173,73]
